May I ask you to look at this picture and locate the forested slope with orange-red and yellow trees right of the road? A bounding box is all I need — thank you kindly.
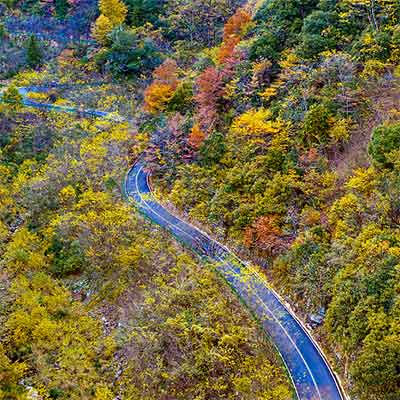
[138,1,400,399]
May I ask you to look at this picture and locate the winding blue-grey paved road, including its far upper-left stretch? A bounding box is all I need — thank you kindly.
[10,87,345,400]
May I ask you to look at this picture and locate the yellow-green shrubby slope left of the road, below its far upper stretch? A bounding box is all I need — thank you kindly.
[0,96,291,400]
